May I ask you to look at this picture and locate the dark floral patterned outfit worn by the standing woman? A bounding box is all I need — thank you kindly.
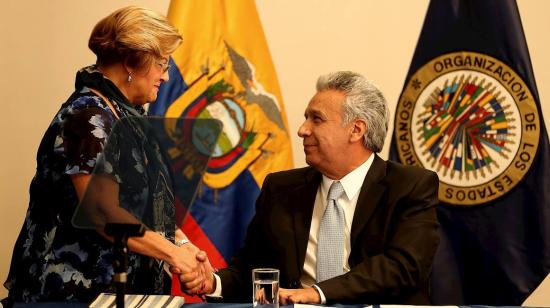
[4,66,174,302]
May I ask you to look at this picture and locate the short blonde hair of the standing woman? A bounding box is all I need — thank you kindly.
[88,6,182,68]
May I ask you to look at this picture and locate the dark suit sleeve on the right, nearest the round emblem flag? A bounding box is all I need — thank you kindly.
[318,171,439,304]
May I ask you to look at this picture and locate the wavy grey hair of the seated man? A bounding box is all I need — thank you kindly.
[317,71,390,153]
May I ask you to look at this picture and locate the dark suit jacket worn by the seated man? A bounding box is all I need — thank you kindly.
[218,156,439,304]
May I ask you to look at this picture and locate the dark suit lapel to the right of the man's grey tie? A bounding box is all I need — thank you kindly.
[351,154,386,244]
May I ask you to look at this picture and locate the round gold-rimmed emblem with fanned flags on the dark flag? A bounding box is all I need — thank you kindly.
[394,52,540,206]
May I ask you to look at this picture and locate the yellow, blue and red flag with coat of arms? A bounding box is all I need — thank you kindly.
[149,0,292,300]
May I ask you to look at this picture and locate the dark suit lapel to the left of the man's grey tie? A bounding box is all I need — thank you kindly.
[291,168,322,273]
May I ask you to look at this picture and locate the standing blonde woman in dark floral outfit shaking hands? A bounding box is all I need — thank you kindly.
[4,6,209,302]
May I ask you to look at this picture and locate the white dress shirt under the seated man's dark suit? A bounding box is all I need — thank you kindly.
[209,154,375,304]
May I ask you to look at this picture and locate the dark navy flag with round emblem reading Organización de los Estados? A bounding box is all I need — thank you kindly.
[391,0,550,305]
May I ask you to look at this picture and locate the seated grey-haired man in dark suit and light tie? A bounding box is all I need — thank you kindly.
[181,72,439,304]
